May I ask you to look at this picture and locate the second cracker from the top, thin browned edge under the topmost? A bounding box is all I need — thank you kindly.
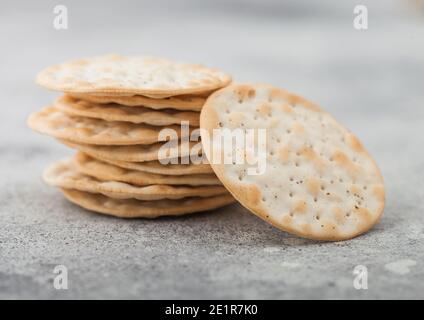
[70,93,206,111]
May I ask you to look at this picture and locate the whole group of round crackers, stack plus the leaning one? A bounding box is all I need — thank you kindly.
[29,56,385,240]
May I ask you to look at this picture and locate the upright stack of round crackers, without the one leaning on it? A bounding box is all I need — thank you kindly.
[28,55,234,217]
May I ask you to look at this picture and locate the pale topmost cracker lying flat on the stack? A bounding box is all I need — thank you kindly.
[37,55,231,98]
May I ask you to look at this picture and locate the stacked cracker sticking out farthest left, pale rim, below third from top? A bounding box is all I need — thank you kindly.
[28,107,196,145]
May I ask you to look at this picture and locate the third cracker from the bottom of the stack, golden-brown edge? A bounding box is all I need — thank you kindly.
[74,153,221,186]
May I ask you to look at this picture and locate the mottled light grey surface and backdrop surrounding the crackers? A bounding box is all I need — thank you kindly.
[0,0,424,299]
